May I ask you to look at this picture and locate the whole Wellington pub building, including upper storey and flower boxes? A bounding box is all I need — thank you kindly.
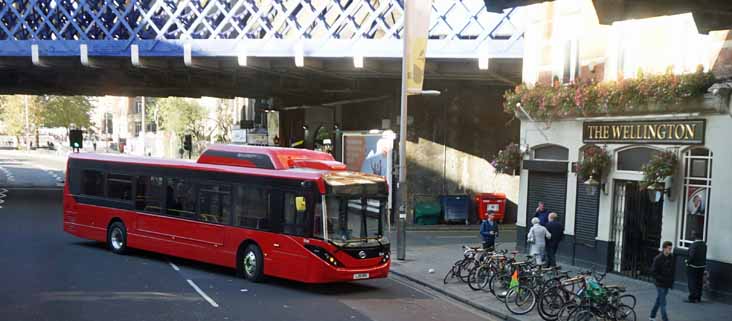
[504,0,732,301]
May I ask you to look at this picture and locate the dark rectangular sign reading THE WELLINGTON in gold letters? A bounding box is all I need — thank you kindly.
[582,119,706,145]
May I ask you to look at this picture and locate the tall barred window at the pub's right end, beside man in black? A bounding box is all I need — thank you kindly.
[679,148,712,248]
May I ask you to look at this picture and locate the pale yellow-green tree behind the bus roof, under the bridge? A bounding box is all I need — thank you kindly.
[153,97,206,140]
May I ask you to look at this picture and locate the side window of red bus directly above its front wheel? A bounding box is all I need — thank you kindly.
[234,185,270,230]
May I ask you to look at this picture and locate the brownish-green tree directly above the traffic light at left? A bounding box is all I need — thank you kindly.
[43,96,92,130]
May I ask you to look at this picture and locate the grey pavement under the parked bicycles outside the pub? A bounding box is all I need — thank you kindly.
[391,227,732,321]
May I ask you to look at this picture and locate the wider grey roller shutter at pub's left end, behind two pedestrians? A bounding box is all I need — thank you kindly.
[526,171,567,227]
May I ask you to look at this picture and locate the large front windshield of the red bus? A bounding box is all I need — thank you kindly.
[323,195,387,247]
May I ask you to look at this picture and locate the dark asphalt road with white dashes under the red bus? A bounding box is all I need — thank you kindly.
[0,152,496,321]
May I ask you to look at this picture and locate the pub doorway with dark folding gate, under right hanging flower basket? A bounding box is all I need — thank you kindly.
[613,180,663,281]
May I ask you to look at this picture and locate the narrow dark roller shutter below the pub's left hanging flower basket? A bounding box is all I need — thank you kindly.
[574,179,600,247]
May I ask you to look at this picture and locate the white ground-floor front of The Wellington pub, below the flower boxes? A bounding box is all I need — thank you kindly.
[517,106,732,301]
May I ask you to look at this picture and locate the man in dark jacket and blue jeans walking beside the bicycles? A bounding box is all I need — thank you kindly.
[650,241,674,321]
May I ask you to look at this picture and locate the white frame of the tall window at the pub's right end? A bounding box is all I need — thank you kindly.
[676,146,714,249]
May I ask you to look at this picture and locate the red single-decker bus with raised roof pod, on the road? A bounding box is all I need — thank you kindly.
[63,145,390,283]
